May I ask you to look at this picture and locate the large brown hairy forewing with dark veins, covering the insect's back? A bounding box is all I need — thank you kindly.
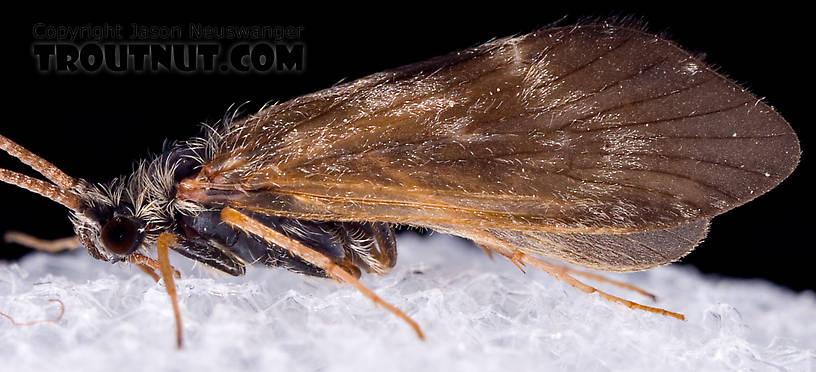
[179,24,800,233]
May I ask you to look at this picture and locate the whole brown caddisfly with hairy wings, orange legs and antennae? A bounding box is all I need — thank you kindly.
[0,23,800,346]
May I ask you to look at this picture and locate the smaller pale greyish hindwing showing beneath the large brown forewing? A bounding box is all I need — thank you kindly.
[427,220,710,271]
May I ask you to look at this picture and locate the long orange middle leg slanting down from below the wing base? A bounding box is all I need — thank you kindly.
[221,207,425,339]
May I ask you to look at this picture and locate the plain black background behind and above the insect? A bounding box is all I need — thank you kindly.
[0,6,816,290]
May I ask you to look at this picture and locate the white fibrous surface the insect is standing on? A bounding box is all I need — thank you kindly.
[0,233,816,372]
